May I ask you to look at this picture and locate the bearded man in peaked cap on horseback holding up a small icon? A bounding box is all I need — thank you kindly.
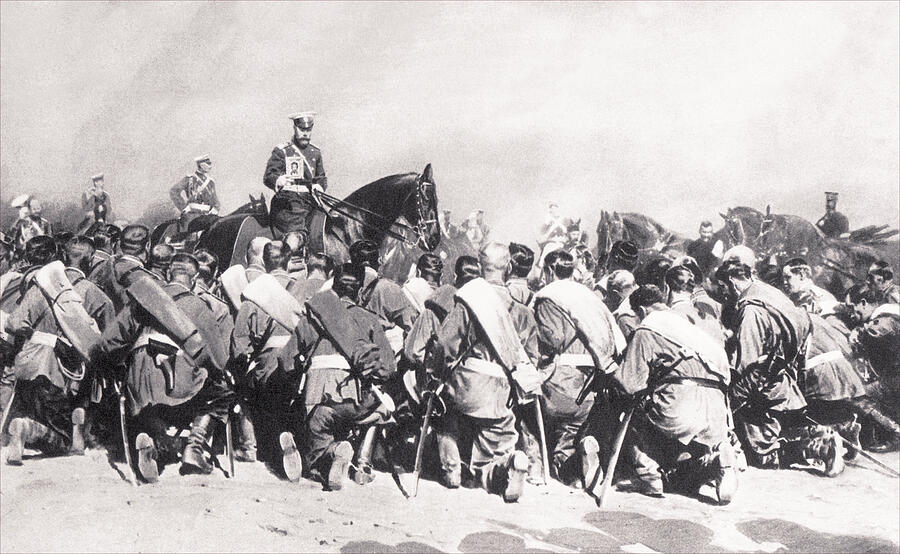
[263,112,328,239]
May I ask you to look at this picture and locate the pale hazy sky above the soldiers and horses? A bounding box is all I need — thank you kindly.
[0,1,900,242]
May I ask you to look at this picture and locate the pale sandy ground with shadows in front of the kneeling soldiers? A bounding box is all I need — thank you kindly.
[0,444,900,552]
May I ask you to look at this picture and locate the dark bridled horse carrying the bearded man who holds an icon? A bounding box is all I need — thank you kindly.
[197,164,440,280]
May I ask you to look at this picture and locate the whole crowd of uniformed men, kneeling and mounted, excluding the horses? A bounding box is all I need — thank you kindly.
[0,113,900,504]
